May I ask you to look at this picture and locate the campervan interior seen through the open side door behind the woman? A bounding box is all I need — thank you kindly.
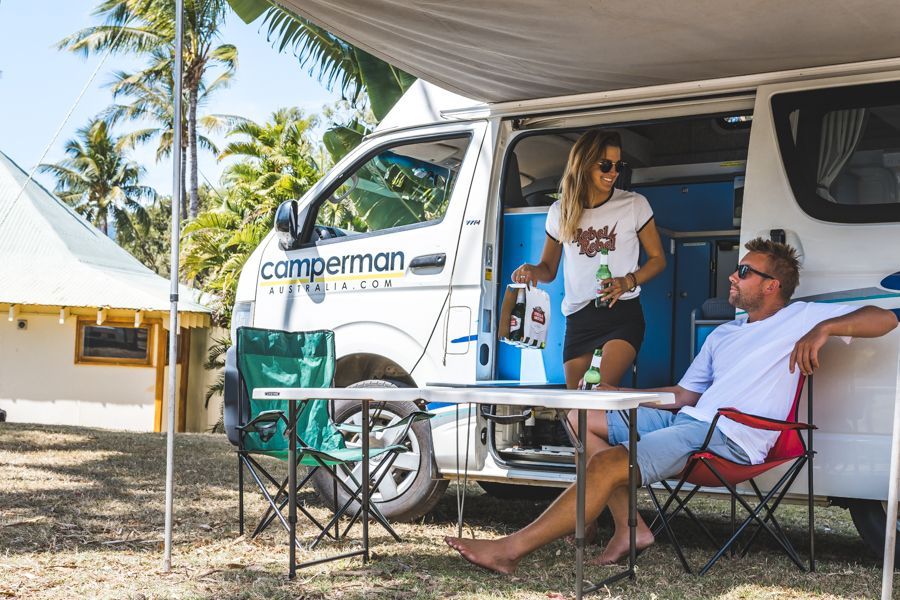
[489,111,752,469]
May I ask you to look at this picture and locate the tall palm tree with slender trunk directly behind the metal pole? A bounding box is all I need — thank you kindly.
[58,0,237,218]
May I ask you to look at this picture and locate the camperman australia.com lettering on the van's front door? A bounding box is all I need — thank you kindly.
[259,251,406,294]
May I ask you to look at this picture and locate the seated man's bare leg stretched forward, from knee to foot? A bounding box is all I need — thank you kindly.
[444,446,628,574]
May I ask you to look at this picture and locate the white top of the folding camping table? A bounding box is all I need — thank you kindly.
[253,386,675,410]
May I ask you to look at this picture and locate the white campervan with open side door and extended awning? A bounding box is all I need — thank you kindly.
[225,2,900,564]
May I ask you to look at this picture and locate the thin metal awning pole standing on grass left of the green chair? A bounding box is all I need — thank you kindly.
[163,0,184,573]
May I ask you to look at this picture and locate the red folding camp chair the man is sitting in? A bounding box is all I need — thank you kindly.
[647,376,816,575]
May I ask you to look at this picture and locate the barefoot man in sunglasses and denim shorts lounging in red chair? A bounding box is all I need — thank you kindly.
[445,238,897,574]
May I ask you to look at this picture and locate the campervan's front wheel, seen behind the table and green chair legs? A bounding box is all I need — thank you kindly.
[312,379,450,521]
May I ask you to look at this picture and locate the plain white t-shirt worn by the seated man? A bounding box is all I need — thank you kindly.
[678,302,859,464]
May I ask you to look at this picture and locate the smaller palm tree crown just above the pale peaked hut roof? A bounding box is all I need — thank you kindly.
[40,119,156,239]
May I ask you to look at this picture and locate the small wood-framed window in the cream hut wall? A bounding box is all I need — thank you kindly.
[75,319,153,366]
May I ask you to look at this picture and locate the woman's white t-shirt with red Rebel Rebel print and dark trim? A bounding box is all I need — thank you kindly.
[546,189,653,316]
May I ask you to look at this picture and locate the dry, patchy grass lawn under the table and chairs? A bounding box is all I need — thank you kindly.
[0,423,900,600]
